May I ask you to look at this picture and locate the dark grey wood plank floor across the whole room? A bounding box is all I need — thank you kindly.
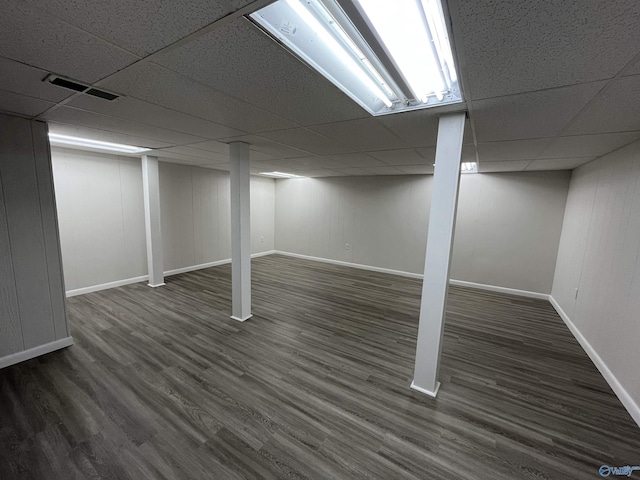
[0,255,640,480]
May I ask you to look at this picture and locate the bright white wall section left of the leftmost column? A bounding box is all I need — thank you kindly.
[52,148,147,290]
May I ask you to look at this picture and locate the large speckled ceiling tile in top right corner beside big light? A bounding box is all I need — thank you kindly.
[456,0,640,99]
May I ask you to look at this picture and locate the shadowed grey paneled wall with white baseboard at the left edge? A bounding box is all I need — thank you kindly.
[0,114,72,368]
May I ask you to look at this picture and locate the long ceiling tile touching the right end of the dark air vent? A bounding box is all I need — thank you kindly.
[99,62,296,133]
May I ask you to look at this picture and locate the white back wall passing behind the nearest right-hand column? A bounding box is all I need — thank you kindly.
[276,172,569,293]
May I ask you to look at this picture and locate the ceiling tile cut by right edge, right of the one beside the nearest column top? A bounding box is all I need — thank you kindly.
[563,75,640,135]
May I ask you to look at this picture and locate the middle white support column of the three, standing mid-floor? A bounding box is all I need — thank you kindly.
[229,142,252,322]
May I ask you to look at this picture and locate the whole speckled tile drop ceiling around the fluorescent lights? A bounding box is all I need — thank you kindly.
[0,0,640,176]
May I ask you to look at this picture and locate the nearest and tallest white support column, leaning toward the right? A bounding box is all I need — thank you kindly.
[411,113,466,397]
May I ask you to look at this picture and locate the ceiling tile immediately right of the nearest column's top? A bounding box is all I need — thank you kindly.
[473,82,604,142]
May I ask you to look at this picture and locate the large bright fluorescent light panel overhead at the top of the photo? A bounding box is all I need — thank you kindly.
[250,0,462,115]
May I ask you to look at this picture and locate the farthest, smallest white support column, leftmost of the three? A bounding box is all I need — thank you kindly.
[142,155,164,287]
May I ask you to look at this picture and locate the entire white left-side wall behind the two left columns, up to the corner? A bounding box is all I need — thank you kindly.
[52,148,275,291]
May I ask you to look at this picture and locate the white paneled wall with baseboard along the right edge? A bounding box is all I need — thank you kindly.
[552,142,640,423]
